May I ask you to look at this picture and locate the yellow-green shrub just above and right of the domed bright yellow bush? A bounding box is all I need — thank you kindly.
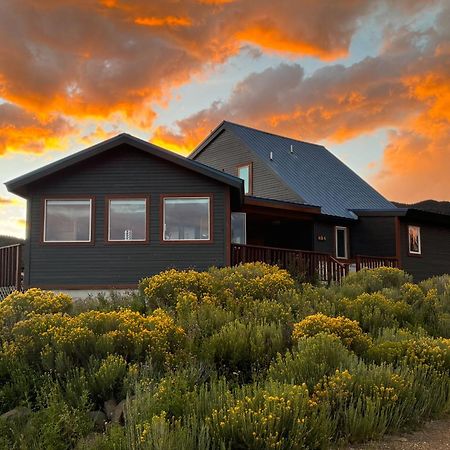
[340,292,413,332]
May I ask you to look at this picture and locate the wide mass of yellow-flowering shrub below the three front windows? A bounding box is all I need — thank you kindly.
[8,309,184,370]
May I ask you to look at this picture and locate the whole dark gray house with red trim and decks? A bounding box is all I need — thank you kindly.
[0,122,450,295]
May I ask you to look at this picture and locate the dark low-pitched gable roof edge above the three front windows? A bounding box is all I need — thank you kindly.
[5,133,244,198]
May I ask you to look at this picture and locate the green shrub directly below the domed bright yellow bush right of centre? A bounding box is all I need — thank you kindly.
[267,333,357,389]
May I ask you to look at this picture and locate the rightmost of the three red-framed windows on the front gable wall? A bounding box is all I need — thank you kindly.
[163,197,211,241]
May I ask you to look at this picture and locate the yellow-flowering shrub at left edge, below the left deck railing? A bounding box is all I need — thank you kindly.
[0,288,72,334]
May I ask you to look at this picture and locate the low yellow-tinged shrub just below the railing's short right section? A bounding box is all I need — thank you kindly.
[343,267,412,293]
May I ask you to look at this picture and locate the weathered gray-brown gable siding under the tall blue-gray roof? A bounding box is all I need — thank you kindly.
[195,130,302,202]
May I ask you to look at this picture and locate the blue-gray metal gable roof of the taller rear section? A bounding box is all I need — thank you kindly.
[189,121,396,219]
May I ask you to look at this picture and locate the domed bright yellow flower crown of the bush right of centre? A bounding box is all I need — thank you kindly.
[292,313,371,353]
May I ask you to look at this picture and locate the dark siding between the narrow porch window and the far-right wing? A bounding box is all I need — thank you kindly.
[351,217,396,256]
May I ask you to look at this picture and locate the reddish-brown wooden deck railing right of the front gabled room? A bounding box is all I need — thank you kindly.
[231,244,398,284]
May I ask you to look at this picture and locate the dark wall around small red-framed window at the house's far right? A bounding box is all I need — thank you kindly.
[400,218,450,282]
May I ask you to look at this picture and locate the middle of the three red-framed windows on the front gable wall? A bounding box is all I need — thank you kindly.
[108,198,147,242]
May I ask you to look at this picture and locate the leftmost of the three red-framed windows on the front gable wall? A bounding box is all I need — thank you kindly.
[44,199,92,242]
